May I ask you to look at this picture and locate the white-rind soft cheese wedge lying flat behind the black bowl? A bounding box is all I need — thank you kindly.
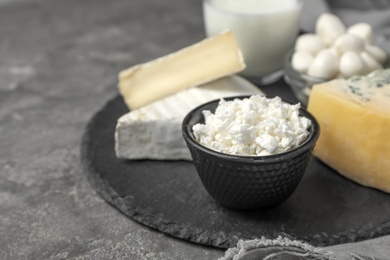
[115,76,262,160]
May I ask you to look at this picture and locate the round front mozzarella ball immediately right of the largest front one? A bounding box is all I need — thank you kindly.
[339,51,367,78]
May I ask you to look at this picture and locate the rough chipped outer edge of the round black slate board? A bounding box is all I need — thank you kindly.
[80,95,390,249]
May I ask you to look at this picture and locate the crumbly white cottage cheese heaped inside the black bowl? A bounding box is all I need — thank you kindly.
[193,95,311,156]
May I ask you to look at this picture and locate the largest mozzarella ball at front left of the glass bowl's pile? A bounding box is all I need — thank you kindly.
[307,49,338,79]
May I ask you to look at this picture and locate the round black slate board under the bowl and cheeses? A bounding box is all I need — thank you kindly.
[81,80,390,249]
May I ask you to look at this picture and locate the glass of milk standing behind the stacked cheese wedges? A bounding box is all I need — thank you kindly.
[203,0,303,84]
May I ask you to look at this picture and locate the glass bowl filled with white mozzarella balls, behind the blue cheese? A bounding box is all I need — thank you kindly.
[284,13,388,105]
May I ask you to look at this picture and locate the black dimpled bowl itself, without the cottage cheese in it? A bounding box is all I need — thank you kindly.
[182,96,319,209]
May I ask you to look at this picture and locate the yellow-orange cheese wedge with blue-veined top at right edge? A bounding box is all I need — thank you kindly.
[308,70,390,192]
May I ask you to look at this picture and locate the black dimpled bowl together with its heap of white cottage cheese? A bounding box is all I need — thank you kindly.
[182,95,320,209]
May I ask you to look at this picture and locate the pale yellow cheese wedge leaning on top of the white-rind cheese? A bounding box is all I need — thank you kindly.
[119,31,245,110]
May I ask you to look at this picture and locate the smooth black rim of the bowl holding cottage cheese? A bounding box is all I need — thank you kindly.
[182,95,320,163]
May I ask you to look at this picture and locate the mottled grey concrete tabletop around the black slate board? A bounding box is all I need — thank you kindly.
[0,0,223,260]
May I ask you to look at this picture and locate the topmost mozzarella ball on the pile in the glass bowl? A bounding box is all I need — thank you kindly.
[315,13,347,46]
